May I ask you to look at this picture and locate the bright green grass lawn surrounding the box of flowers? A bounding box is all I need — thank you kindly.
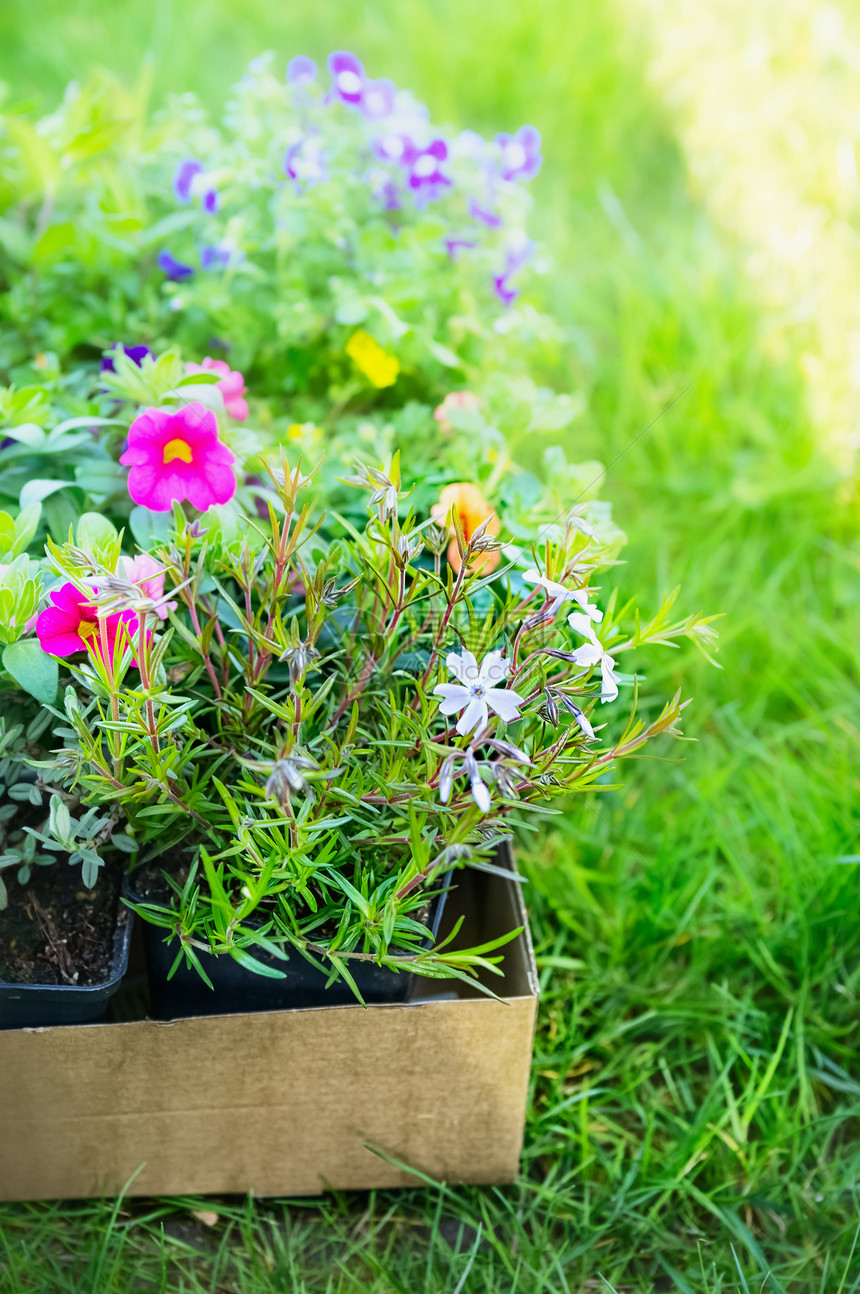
[0,0,860,1294]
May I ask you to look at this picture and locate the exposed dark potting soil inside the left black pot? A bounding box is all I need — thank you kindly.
[0,854,131,987]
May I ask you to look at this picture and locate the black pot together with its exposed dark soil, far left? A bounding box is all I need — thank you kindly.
[0,855,131,1027]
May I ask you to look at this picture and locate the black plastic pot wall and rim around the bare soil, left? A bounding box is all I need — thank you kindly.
[0,906,134,1029]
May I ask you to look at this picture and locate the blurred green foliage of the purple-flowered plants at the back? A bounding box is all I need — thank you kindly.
[0,56,559,421]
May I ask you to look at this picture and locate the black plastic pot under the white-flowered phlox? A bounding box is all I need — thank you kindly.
[125,873,450,1020]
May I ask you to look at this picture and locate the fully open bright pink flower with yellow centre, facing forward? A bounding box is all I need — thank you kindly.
[120,401,235,512]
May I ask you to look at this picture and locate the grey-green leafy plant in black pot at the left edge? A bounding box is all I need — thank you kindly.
[0,538,132,1029]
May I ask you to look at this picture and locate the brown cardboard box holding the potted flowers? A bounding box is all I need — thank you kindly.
[0,848,538,1200]
